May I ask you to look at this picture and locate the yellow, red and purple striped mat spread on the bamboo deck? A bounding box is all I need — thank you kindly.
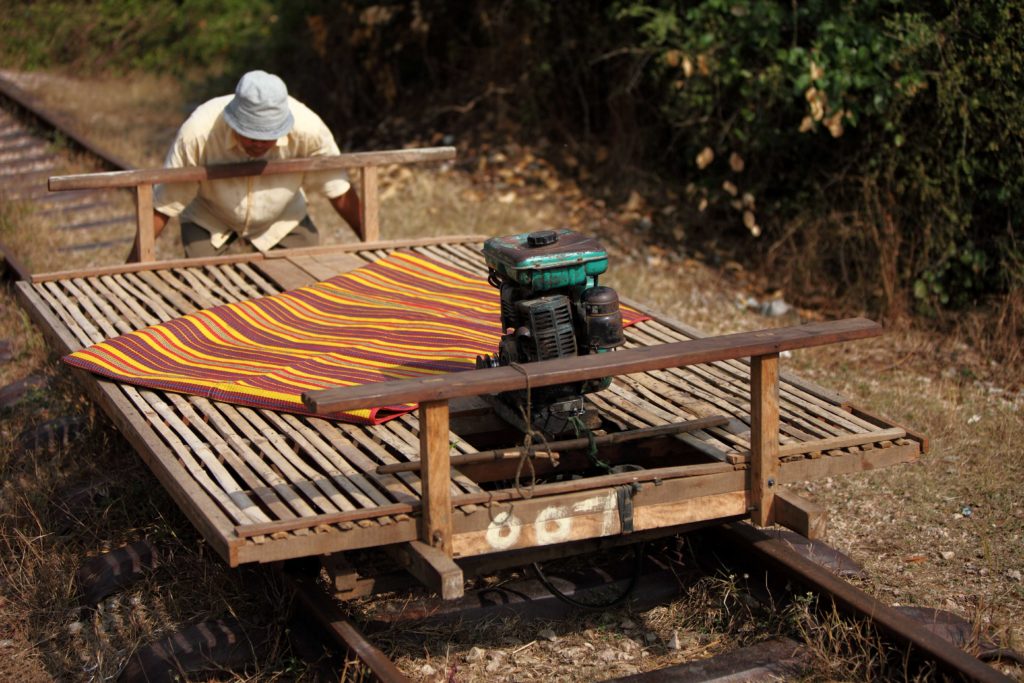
[65,252,644,424]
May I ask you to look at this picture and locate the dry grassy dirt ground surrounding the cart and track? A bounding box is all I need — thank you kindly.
[0,74,1024,681]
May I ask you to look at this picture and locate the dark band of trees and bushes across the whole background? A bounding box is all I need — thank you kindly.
[0,0,1024,312]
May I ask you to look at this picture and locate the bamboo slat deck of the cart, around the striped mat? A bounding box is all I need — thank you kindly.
[12,238,921,566]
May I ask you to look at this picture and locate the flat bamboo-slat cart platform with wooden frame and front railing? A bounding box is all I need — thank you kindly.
[16,152,927,597]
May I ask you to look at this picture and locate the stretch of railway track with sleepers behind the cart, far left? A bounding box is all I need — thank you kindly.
[0,77,135,278]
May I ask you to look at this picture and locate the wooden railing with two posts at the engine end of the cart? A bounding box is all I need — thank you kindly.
[302,317,882,556]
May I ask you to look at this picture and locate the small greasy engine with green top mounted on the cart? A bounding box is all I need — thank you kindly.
[476,228,625,434]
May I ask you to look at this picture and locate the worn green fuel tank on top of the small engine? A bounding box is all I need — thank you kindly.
[483,228,608,292]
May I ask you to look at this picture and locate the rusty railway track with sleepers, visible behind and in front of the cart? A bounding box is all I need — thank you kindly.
[0,72,1014,683]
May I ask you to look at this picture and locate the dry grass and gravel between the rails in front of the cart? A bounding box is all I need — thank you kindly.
[375,571,782,683]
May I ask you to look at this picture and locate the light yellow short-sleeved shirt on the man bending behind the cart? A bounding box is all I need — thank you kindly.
[154,95,351,251]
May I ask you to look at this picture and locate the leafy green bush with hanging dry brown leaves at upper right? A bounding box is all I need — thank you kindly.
[615,0,1024,310]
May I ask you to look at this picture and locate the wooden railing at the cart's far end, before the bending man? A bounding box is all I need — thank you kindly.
[49,147,455,261]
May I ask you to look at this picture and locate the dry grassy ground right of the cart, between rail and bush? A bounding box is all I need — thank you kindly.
[802,331,1024,649]
